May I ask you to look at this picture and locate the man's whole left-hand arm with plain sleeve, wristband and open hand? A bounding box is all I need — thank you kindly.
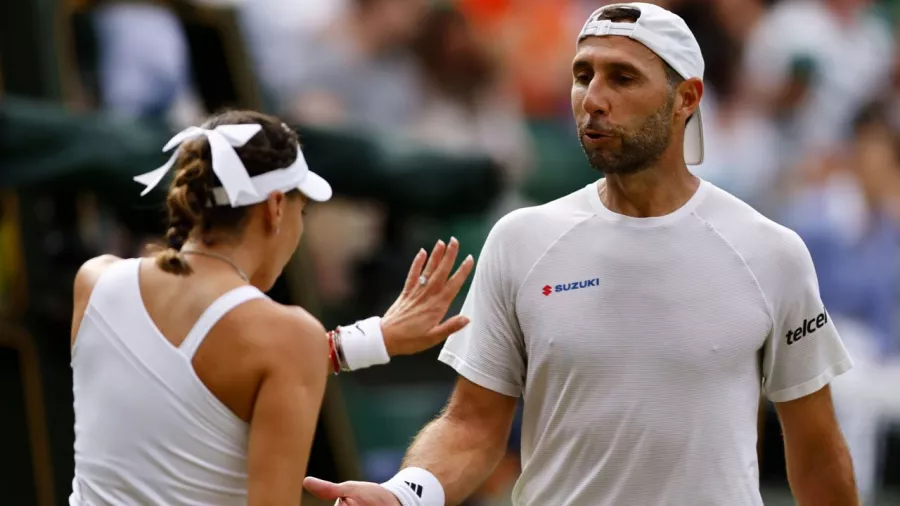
[304,213,533,506]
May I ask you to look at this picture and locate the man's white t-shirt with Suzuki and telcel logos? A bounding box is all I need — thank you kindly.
[440,182,852,506]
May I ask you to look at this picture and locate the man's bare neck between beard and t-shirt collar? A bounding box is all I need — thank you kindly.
[598,163,700,218]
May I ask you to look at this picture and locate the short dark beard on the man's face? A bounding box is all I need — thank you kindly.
[578,94,675,174]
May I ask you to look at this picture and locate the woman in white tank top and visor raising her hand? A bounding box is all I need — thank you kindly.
[69,111,473,506]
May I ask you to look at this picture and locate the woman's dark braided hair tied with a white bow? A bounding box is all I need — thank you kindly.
[156,111,299,275]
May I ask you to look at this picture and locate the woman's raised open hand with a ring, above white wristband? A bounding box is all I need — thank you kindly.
[381,238,475,357]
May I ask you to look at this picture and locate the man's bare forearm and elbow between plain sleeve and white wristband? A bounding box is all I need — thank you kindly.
[403,377,517,504]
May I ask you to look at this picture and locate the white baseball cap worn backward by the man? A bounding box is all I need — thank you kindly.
[578,2,705,165]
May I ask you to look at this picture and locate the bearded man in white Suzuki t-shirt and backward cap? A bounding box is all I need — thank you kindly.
[306,3,858,506]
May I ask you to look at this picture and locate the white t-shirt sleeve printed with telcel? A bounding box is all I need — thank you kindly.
[763,233,853,402]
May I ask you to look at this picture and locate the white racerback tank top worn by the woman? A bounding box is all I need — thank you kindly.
[69,258,266,506]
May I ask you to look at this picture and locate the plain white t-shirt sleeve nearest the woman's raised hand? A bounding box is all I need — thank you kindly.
[438,220,525,397]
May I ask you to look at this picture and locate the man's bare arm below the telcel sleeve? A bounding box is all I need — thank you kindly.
[775,385,860,506]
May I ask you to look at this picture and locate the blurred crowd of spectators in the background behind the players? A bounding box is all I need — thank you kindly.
[26,0,900,504]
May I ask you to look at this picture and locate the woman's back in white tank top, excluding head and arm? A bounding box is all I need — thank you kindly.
[70,259,271,505]
